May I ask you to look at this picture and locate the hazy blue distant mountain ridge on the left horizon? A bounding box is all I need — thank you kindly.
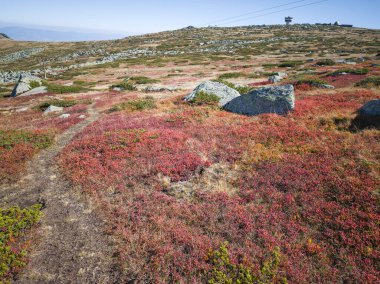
[0,27,125,42]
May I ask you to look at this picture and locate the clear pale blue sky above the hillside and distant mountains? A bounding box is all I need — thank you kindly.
[0,0,380,34]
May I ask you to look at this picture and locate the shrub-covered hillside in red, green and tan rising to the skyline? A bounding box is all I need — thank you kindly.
[0,23,380,283]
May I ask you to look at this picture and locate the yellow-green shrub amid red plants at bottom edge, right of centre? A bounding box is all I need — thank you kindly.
[207,243,287,284]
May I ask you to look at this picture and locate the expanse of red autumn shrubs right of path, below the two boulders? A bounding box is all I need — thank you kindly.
[60,90,380,283]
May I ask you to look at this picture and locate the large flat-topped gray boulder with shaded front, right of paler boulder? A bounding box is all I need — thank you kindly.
[224,85,295,115]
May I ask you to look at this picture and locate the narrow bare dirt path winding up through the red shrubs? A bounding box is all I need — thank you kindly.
[0,105,119,283]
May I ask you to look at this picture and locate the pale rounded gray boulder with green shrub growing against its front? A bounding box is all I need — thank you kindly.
[184,81,240,107]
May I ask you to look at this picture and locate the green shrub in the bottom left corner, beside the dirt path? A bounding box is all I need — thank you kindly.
[0,205,42,283]
